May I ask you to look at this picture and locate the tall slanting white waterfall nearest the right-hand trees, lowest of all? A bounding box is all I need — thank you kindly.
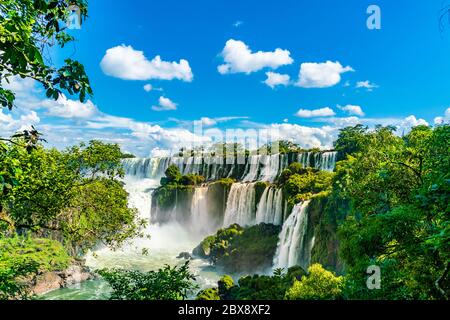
[273,201,312,270]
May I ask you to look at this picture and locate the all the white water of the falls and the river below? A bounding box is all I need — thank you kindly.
[41,152,330,299]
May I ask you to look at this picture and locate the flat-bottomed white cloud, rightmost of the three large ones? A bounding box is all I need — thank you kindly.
[297,61,354,88]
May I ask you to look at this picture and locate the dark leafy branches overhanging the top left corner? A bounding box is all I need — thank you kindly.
[0,0,92,109]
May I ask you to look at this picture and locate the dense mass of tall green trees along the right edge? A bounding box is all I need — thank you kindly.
[333,125,450,299]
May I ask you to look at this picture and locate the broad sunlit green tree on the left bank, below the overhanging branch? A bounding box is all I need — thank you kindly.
[0,140,141,253]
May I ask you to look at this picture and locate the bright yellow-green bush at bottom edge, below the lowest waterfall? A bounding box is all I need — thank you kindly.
[286,264,344,300]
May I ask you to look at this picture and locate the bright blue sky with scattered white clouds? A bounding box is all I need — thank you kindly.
[0,0,450,155]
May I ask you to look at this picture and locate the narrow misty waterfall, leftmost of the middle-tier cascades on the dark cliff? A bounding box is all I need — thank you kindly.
[191,187,214,235]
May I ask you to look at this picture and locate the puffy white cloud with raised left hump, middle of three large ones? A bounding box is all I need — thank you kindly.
[217,39,294,74]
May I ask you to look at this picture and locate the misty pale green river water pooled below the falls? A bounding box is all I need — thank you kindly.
[40,225,220,300]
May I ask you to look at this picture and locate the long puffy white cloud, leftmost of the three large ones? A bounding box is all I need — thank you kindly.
[100,45,193,82]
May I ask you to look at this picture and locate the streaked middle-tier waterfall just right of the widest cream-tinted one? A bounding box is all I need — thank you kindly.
[256,187,283,225]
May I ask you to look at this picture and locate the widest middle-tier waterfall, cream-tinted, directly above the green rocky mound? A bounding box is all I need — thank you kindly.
[223,183,256,227]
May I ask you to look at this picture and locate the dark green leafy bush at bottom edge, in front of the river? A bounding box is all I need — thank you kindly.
[98,261,197,300]
